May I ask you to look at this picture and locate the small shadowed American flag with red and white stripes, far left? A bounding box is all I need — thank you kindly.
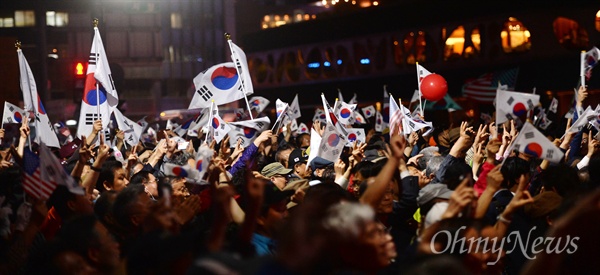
[23,148,56,199]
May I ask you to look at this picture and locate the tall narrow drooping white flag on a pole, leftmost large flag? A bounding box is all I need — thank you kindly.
[17,49,60,148]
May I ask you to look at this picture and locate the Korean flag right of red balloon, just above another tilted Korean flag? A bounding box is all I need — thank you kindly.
[496,90,540,125]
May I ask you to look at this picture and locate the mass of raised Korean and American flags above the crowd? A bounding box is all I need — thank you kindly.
[2,19,600,275]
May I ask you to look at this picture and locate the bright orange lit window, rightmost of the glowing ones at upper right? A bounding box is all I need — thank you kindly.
[500,17,531,53]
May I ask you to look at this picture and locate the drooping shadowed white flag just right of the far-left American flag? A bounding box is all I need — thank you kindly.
[39,143,85,195]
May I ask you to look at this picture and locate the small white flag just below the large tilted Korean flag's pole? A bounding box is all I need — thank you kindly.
[229,116,271,147]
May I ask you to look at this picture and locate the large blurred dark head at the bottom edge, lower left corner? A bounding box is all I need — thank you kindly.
[58,215,120,273]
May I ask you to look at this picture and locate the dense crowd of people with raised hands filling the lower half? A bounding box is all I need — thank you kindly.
[0,89,600,274]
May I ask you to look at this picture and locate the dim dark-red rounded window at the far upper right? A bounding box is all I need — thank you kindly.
[552,17,589,50]
